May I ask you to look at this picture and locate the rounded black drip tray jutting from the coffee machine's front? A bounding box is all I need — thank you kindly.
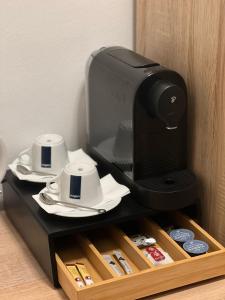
[134,170,197,210]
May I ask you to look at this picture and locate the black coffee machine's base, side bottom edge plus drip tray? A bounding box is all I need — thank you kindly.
[89,148,197,211]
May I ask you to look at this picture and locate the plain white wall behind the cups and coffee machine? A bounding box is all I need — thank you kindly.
[0,0,133,164]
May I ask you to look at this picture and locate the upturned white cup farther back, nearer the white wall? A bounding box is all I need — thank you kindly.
[18,134,69,175]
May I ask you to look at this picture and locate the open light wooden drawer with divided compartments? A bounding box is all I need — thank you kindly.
[56,213,225,300]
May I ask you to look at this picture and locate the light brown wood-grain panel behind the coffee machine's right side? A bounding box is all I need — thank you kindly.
[136,0,225,243]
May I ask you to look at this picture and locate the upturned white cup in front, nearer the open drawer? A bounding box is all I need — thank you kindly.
[46,162,103,207]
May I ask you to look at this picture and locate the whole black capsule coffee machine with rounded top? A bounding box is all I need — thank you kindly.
[87,47,197,210]
